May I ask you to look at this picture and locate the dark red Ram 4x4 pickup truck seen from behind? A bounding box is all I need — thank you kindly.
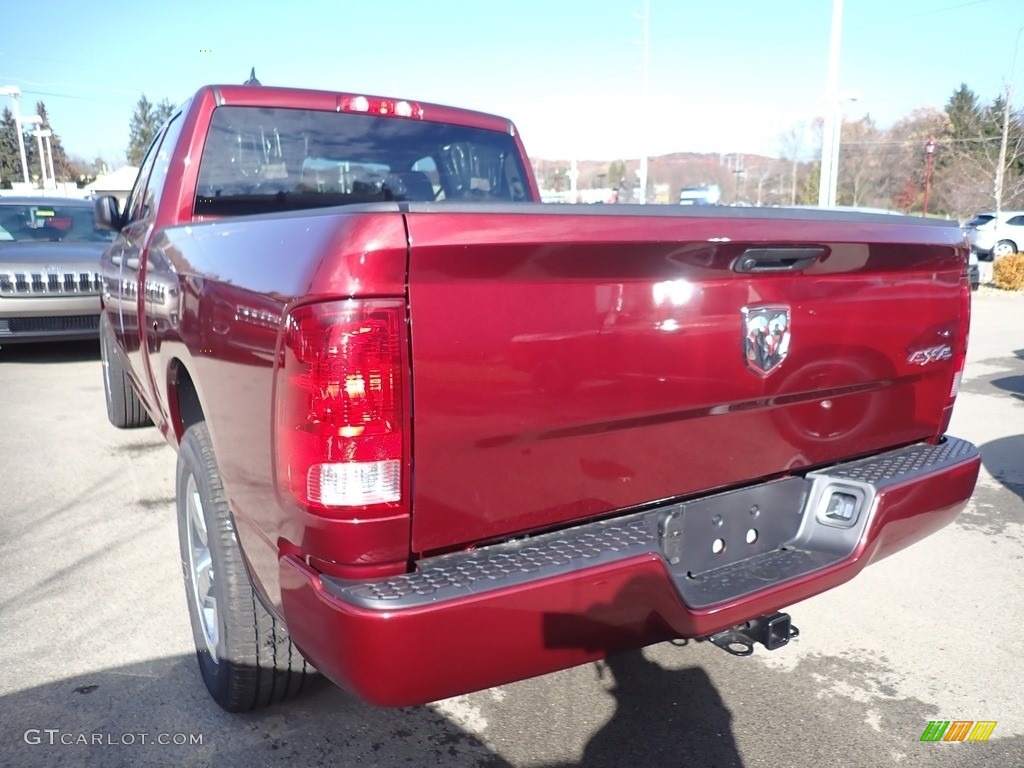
[96,81,979,711]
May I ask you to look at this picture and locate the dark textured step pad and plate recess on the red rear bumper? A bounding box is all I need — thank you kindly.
[321,437,978,610]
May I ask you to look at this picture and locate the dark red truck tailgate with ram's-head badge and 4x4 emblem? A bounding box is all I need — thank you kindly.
[407,206,968,553]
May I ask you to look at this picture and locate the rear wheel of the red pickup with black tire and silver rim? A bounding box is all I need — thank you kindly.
[175,422,312,712]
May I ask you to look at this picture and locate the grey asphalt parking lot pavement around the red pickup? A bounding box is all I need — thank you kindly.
[0,289,1024,768]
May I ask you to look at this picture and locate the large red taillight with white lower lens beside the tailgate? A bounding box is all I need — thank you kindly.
[274,299,406,518]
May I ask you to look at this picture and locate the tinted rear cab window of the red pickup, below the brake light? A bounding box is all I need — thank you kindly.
[194,106,528,216]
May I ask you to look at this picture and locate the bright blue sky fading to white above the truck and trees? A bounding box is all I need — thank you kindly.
[0,0,1024,166]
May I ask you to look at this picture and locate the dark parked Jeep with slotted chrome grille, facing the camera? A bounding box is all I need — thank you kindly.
[0,198,114,344]
